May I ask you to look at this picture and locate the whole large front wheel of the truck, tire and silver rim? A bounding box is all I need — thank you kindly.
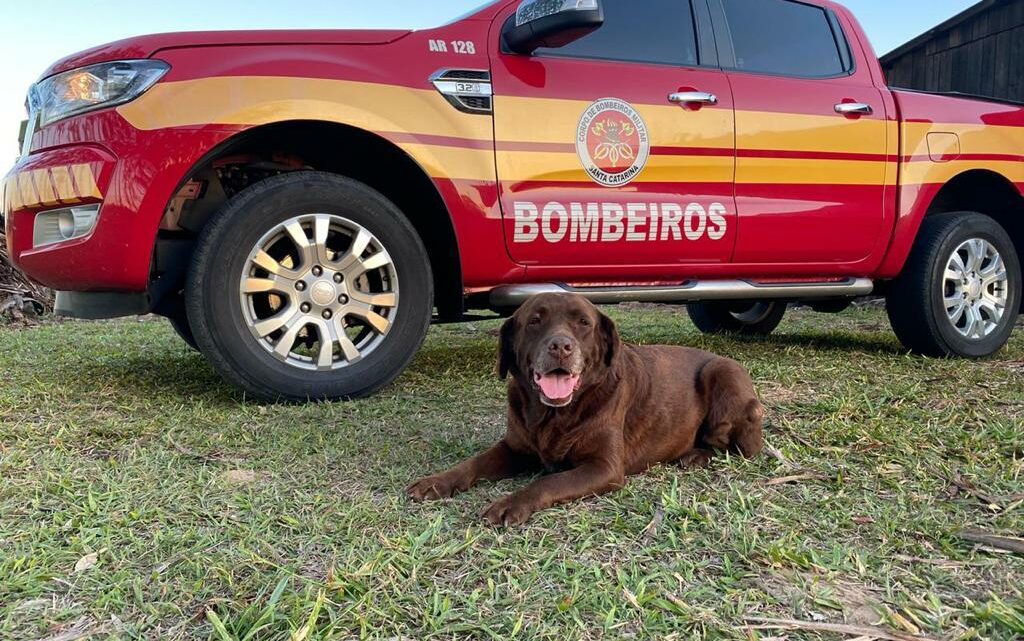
[185,172,433,401]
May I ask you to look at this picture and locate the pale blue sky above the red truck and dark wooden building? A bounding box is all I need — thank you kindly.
[0,0,975,158]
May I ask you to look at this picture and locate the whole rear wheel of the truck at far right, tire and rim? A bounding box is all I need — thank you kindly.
[887,212,1021,358]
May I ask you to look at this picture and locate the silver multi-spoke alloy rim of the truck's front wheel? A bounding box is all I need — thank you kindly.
[239,214,398,371]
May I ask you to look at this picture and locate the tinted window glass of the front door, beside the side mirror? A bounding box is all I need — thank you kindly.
[535,0,697,67]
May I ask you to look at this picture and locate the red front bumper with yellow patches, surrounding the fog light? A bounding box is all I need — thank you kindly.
[0,105,237,294]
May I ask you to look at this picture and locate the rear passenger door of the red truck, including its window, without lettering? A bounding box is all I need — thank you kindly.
[711,0,896,271]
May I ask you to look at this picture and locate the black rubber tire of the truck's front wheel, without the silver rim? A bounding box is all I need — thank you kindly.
[185,171,433,401]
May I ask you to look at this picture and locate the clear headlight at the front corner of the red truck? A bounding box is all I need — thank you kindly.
[29,60,171,128]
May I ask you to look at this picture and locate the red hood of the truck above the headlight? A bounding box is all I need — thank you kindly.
[42,30,412,78]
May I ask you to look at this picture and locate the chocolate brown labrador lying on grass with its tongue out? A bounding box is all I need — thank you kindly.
[409,294,764,525]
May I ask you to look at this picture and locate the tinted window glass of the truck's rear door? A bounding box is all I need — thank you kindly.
[722,0,849,78]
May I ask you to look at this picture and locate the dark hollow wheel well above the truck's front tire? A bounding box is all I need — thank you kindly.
[155,120,464,318]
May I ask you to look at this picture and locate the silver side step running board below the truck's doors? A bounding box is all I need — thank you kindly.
[490,279,874,308]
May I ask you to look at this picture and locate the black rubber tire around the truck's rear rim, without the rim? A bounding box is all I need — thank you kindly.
[886,212,1021,358]
